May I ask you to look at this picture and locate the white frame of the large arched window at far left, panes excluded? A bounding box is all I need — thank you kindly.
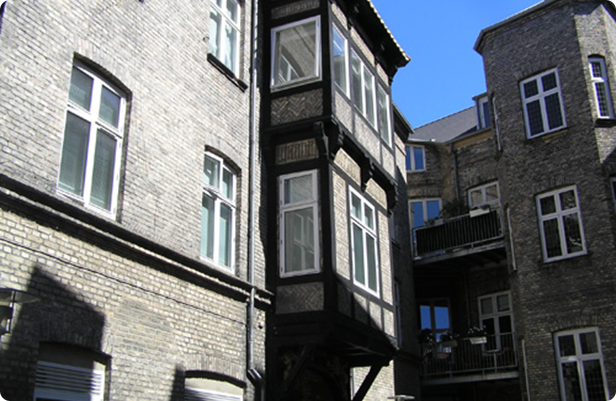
[57,62,126,218]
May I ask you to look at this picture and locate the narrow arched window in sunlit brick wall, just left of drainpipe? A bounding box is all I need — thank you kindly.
[201,153,236,269]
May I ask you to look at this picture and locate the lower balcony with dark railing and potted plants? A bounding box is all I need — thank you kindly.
[421,333,519,385]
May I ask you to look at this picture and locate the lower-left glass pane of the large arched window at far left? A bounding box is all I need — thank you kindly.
[58,113,90,196]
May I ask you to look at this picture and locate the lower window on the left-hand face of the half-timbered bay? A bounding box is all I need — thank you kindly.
[279,170,319,277]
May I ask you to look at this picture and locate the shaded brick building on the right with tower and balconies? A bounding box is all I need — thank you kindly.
[407,0,616,401]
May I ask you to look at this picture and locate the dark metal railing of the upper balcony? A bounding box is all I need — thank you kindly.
[413,208,503,258]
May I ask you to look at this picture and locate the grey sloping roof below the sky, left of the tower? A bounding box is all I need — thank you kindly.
[410,106,477,143]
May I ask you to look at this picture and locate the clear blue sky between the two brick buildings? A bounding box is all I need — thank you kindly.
[372,0,539,128]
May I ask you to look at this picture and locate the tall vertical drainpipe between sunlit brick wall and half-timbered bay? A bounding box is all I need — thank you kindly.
[246,0,265,401]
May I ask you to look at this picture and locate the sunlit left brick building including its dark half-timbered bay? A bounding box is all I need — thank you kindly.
[0,0,418,401]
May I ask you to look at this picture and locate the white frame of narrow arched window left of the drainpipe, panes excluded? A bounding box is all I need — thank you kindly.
[199,152,237,271]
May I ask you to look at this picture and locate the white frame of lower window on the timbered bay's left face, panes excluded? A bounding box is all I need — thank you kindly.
[278,170,321,278]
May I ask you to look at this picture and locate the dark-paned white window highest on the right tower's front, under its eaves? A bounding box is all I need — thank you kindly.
[520,69,565,138]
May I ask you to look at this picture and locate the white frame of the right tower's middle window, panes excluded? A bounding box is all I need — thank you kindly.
[536,186,586,262]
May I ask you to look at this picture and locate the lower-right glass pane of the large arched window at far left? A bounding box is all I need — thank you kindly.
[90,130,116,210]
